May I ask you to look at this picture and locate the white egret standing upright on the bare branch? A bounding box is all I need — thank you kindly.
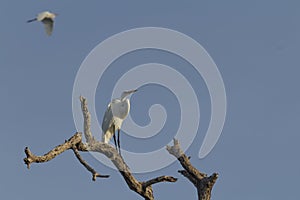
[102,90,137,154]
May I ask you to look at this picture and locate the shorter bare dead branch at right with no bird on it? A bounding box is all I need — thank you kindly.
[167,139,218,200]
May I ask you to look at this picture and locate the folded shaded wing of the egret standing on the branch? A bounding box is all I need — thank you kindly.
[102,104,114,143]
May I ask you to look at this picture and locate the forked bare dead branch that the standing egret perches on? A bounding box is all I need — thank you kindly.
[24,96,177,200]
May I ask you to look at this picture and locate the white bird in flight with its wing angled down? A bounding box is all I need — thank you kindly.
[27,11,57,36]
